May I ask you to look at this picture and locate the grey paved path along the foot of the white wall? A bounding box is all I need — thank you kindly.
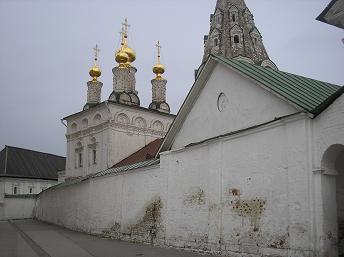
[0,220,214,257]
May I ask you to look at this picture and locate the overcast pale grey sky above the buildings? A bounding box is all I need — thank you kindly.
[0,0,344,155]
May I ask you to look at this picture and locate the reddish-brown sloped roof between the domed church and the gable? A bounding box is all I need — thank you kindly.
[113,138,163,168]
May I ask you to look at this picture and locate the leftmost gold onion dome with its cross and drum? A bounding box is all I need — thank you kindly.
[84,45,103,110]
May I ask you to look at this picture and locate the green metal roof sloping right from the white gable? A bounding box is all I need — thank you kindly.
[212,55,344,116]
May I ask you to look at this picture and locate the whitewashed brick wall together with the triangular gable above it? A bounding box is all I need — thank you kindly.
[36,64,344,254]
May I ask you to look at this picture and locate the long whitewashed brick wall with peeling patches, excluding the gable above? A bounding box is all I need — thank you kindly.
[36,100,344,256]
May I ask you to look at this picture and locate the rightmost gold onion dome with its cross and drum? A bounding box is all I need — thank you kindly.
[149,41,170,113]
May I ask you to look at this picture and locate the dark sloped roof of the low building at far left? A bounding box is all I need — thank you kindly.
[0,146,66,180]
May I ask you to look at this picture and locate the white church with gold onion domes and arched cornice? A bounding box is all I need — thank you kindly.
[60,25,175,181]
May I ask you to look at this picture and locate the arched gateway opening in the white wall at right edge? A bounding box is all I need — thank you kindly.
[321,145,344,257]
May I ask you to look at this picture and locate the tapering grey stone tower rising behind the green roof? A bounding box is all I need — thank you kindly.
[203,0,277,69]
